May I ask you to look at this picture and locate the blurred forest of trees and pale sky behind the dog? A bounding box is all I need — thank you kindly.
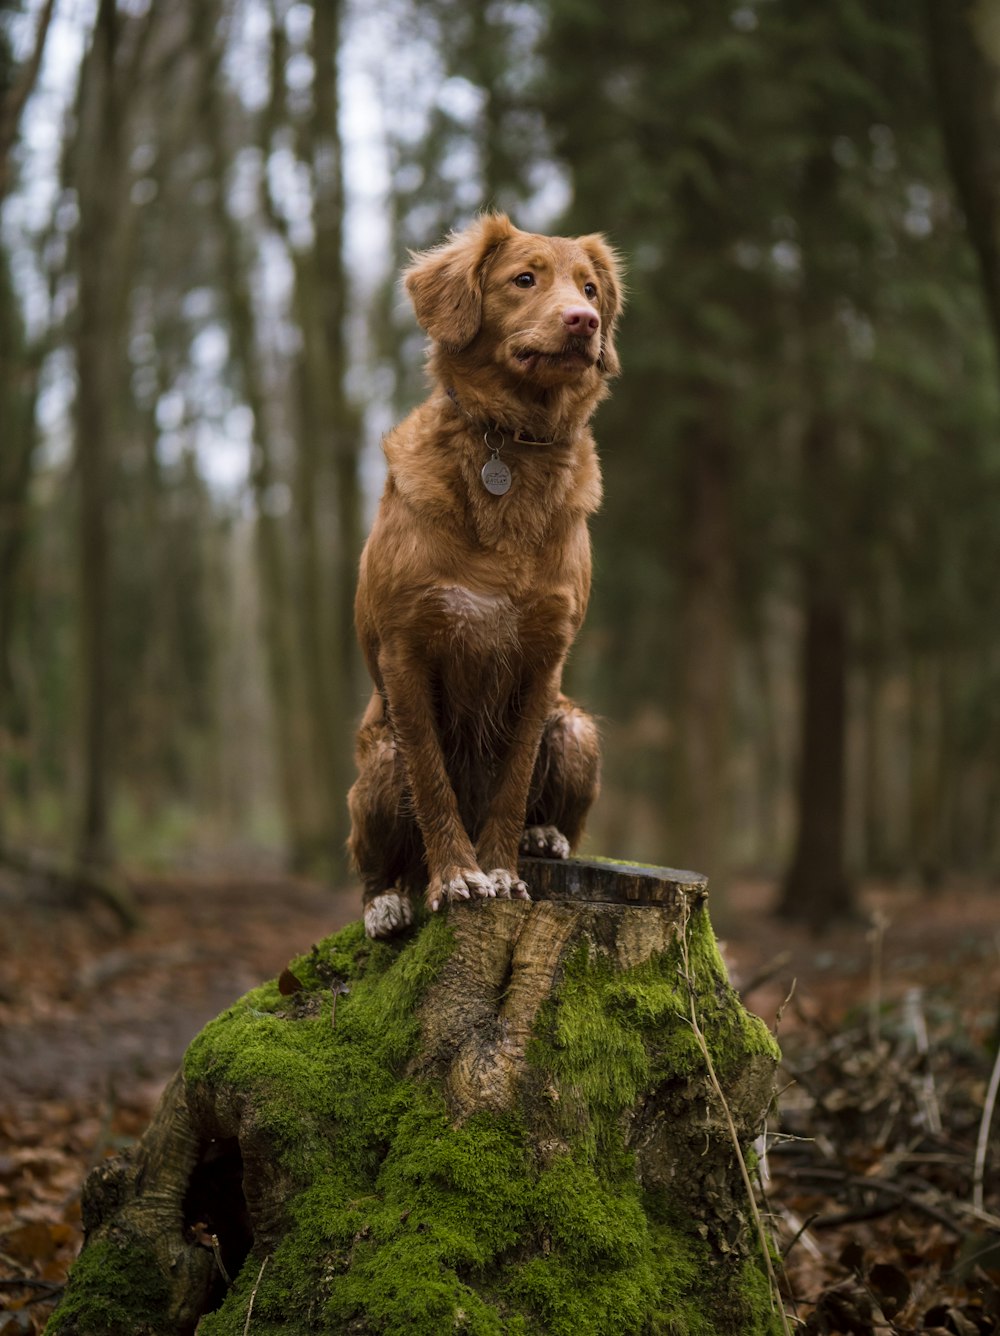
[0,0,1000,923]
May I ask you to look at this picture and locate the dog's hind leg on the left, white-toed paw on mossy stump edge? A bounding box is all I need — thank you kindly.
[347,692,422,937]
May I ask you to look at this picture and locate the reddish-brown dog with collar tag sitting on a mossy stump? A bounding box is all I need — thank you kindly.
[348,214,622,938]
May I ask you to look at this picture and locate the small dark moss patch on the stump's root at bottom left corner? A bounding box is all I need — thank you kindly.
[45,1232,170,1336]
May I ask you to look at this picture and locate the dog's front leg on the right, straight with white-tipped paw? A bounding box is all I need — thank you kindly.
[478,669,559,900]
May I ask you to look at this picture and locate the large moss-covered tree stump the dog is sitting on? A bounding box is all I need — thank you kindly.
[48,859,781,1336]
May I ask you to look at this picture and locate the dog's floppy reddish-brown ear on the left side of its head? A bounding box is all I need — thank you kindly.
[403,214,517,353]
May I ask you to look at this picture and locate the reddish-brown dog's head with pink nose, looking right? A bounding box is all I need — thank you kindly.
[405,214,622,389]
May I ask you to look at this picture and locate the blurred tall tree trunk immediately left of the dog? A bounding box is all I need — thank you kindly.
[275,0,362,874]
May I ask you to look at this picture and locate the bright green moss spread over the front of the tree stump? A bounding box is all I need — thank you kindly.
[62,897,778,1336]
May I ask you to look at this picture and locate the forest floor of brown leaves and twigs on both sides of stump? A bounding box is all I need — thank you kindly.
[0,872,1000,1336]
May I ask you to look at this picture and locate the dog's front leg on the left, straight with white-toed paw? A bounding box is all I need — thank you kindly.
[379,645,497,910]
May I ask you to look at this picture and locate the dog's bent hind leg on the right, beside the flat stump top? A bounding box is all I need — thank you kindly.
[521,696,601,858]
